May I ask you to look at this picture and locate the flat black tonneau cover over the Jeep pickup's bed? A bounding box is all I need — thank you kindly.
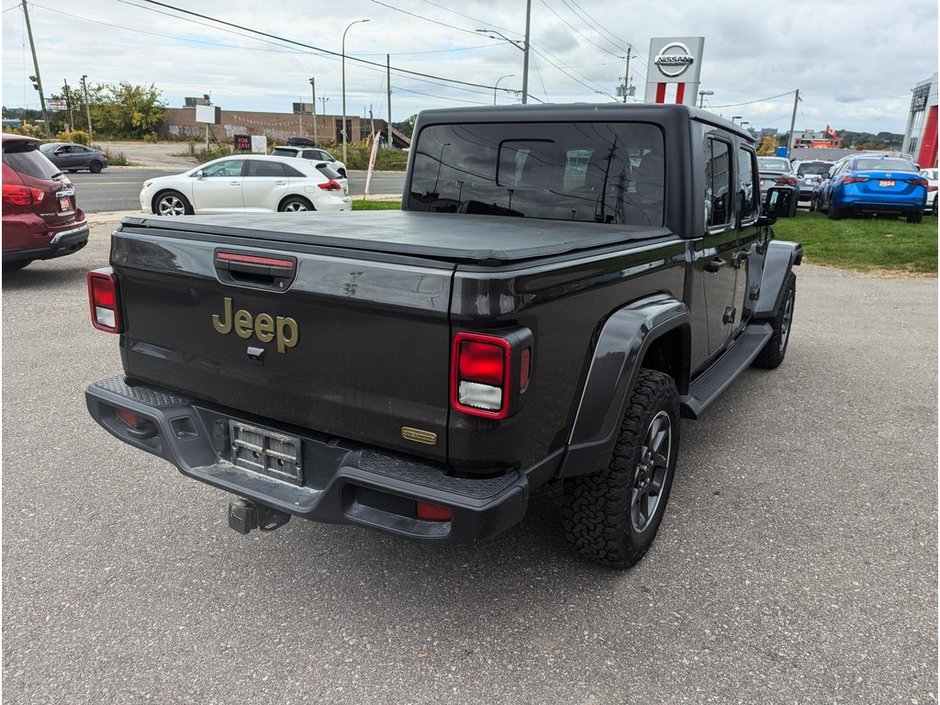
[121,211,670,264]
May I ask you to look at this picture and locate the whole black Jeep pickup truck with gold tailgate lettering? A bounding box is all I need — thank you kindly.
[86,104,802,567]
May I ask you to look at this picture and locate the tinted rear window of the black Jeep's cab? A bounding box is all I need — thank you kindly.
[408,122,665,226]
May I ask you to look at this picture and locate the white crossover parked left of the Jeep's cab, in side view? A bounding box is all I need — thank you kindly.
[140,155,351,215]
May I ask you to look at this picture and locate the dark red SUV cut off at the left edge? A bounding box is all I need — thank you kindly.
[3,133,88,271]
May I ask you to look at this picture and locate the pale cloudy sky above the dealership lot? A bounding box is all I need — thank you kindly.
[2,0,937,133]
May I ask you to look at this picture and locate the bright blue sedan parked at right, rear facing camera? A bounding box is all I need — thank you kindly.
[816,154,927,223]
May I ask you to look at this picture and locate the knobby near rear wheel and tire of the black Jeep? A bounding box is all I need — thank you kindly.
[562,369,679,568]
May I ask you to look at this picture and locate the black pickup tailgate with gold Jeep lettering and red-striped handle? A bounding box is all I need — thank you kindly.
[111,221,453,461]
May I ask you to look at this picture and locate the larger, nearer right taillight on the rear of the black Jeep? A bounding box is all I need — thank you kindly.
[451,333,512,419]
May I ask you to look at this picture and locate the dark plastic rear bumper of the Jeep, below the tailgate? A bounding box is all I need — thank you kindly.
[85,375,529,542]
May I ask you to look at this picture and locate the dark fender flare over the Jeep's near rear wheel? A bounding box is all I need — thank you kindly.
[557,294,690,478]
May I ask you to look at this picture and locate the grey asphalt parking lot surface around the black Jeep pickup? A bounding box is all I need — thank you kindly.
[2,216,937,705]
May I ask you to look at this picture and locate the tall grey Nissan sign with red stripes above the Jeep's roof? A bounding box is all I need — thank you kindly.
[646,37,705,105]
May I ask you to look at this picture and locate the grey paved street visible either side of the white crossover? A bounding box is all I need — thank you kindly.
[74,165,405,213]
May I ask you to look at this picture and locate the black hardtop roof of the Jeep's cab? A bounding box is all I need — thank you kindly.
[417,103,754,141]
